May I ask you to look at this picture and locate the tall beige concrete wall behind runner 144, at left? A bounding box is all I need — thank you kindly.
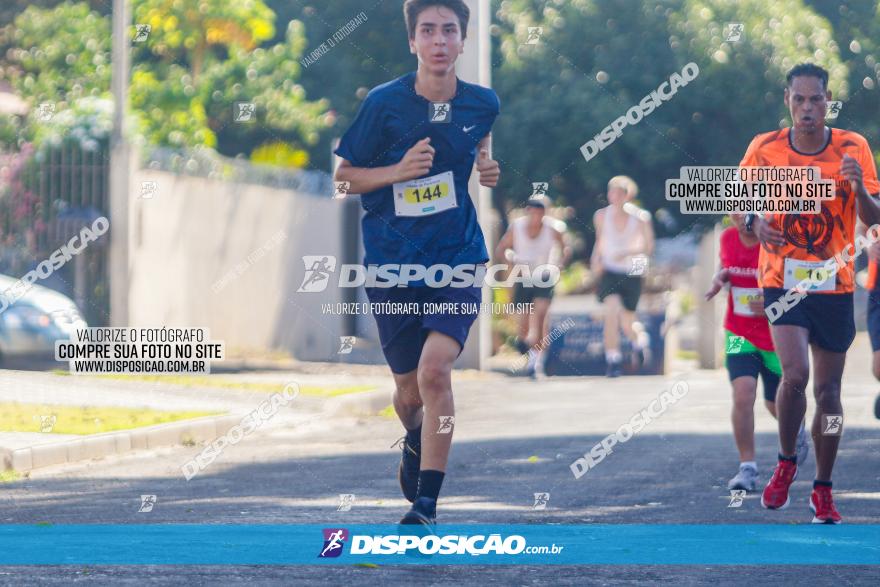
[128,170,354,360]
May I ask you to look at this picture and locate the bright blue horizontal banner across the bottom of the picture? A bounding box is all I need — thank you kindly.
[0,524,880,565]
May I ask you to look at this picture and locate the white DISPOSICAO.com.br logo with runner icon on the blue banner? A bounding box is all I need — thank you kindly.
[320,528,564,558]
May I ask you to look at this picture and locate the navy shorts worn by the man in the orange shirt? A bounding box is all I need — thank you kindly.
[764,287,856,353]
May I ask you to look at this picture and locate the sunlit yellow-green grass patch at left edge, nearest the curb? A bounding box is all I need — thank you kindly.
[0,403,224,435]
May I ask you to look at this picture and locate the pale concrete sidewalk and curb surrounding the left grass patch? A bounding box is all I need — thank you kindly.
[0,371,390,473]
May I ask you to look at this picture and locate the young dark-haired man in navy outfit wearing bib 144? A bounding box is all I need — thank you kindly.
[336,0,500,524]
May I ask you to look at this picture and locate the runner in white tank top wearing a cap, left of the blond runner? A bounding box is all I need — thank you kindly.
[495,195,571,375]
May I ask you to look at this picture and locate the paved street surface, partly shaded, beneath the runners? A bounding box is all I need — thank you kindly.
[0,334,880,585]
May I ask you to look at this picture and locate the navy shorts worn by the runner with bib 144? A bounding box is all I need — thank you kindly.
[365,286,482,375]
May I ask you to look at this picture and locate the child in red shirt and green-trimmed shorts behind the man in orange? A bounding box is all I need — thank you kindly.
[706,214,810,491]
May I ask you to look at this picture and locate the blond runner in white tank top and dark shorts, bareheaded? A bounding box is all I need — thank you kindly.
[590,175,654,377]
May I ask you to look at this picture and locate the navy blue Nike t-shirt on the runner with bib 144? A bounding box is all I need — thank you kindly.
[336,73,500,267]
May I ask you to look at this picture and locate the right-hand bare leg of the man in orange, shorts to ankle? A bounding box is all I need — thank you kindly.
[812,345,846,481]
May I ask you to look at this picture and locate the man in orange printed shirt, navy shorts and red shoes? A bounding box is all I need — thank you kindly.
[741,63,880,524]
